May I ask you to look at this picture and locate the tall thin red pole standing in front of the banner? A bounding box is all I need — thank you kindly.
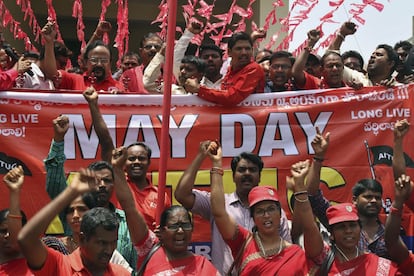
[156,0,177,224]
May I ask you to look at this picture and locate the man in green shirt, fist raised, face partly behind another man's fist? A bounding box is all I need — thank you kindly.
[44,115,137,270]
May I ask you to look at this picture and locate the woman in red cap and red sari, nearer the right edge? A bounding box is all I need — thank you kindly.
[319,203,397,275]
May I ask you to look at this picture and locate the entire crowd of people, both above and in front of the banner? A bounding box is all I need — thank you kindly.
[0,16,414,276]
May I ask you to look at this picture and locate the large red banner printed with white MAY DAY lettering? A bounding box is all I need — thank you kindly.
[0,85,414,253]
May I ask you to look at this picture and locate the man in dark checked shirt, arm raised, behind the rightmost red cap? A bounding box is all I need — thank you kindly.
[307,128,388,258]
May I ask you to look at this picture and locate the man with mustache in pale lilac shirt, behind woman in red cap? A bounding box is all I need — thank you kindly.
[174,140,291,274]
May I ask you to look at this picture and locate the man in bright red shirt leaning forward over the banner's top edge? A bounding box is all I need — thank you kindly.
[184,32,265,106]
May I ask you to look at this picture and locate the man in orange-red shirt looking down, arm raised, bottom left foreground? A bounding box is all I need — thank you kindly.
[18,169,130,276]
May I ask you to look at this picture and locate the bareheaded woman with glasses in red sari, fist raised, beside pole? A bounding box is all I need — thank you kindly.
[112,147,219,276]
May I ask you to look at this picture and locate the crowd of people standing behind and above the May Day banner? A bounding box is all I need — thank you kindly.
[0,19,414,102]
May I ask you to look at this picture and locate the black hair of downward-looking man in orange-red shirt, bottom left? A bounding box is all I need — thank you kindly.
[80,207,119,240]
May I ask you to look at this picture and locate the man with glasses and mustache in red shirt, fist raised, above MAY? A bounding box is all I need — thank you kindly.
[42,22,124,93]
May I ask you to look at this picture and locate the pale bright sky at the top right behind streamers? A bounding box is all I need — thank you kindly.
[289,0,414,61]
